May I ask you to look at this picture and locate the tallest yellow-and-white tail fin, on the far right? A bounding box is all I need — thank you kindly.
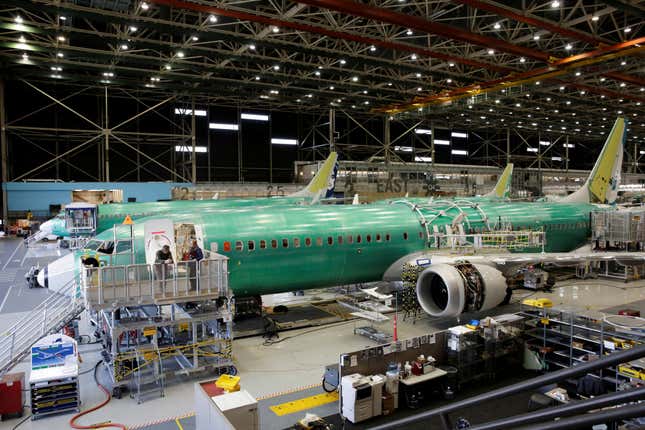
[561,117,627,204]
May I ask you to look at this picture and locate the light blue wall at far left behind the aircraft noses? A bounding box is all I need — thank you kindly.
[2,182,192,216]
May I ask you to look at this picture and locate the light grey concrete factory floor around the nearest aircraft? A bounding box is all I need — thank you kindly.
[0,238,645,430]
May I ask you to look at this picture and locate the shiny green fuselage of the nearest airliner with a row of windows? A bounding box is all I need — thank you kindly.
[83,199,612,296]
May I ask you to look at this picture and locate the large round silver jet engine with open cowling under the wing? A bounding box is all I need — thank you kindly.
[417,263,506,317]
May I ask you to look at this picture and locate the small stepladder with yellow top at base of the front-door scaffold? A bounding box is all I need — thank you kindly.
[130,345,165,404]
